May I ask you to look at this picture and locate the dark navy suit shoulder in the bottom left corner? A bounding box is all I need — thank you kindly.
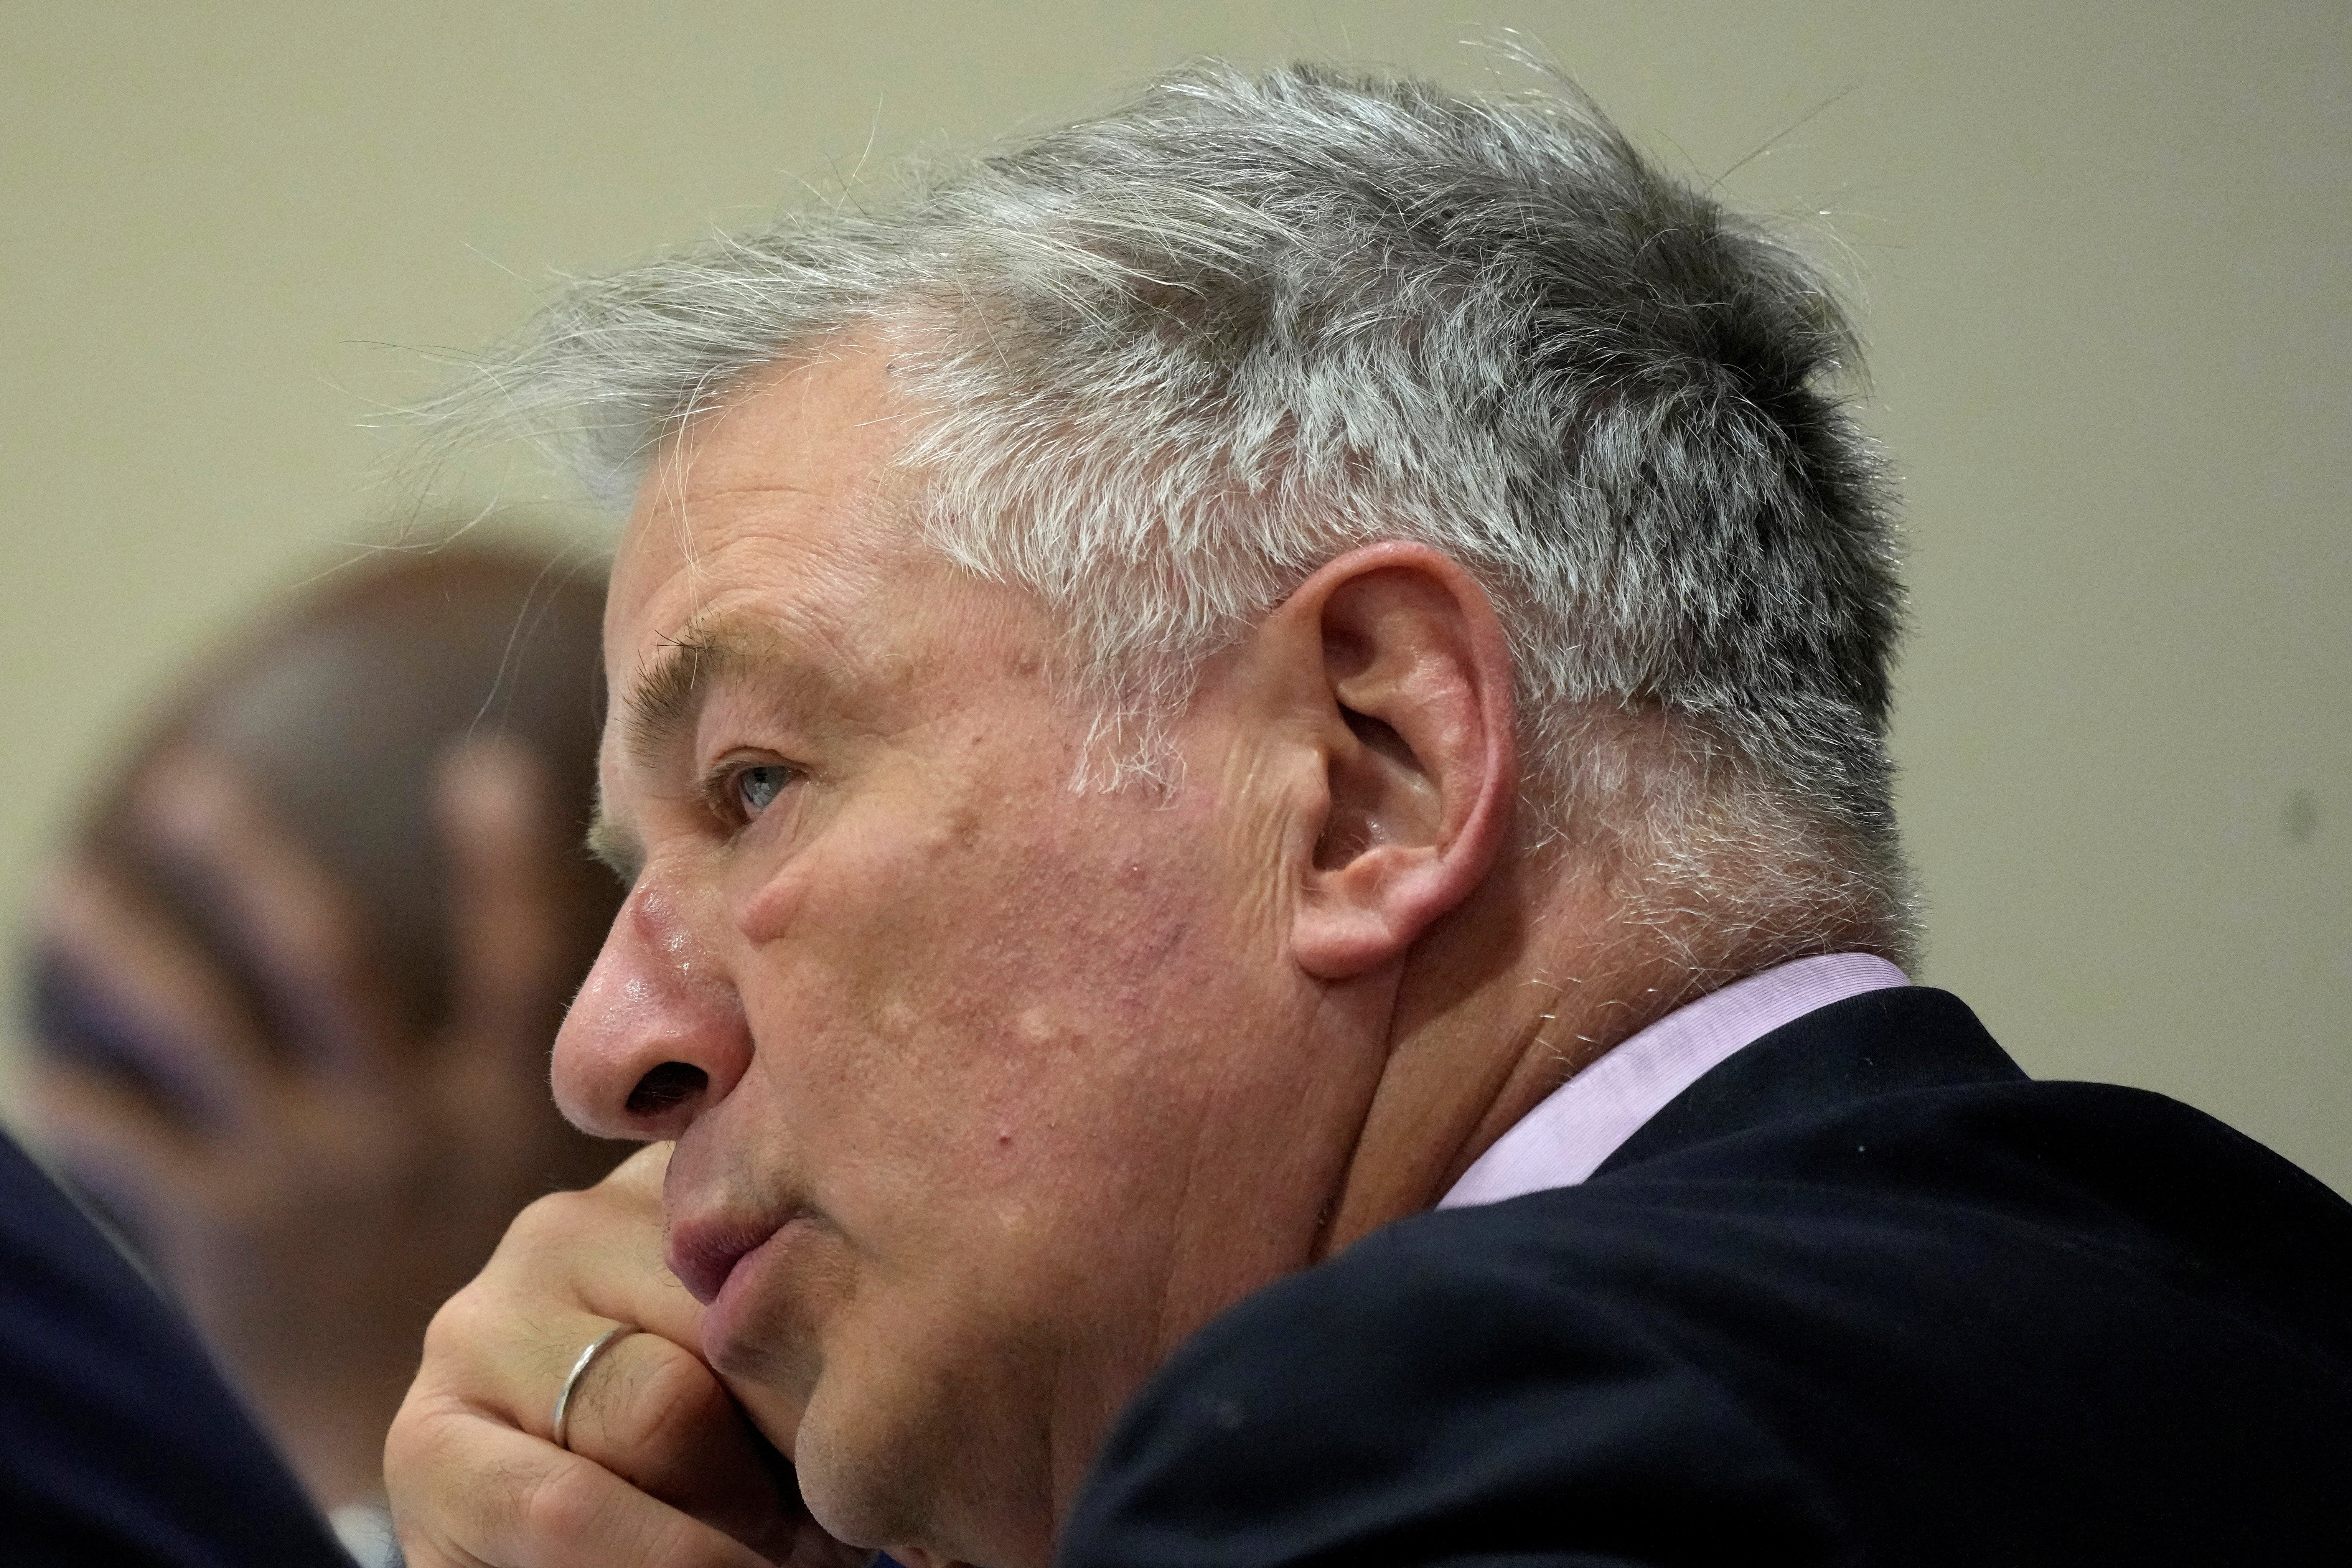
[0,1136,351,1568]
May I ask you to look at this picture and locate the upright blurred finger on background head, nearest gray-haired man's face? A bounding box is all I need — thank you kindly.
[435,740,569,1074]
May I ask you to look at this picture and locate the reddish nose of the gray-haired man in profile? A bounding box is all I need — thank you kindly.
[555,874,750,1138]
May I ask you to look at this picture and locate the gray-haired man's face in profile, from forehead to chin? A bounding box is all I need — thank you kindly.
[555,355,1369,1556]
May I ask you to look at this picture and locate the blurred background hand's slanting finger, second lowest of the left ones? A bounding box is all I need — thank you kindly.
[38,861,270,1131]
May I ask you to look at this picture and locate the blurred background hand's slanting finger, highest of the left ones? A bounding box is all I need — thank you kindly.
[134,748,397,1077]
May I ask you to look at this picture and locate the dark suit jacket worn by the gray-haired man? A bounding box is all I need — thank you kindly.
[1061,988,2352,1568]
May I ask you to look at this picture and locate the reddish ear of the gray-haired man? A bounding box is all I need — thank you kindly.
[1265,543,1520,980]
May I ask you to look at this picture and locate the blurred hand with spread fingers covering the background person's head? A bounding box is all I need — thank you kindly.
[31,743,614,1507]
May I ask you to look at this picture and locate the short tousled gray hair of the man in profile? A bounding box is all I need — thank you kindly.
[437,63,1907,966]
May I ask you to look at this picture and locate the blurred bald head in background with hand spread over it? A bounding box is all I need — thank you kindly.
[28,546,618,1509]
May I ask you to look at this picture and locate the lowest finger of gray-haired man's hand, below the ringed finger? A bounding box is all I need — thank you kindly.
[383,1397,767,1568]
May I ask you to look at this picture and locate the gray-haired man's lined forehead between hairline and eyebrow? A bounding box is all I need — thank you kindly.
[602,353,1068,790]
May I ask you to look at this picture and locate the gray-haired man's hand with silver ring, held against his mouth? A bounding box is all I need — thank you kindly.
[383,1145,873,1568]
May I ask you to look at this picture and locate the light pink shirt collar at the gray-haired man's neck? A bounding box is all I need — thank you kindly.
[1437,952,1910,1209]
